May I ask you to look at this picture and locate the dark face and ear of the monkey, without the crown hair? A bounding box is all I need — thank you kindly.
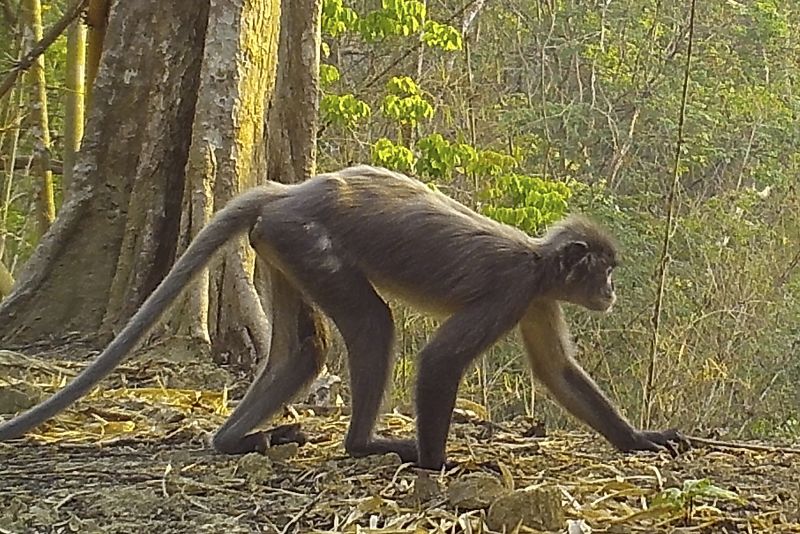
[564,241,617,312]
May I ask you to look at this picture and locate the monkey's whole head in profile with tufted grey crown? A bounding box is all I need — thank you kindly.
[543,216,618,312]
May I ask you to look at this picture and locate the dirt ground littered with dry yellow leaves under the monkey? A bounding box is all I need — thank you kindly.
[0,351,800,534]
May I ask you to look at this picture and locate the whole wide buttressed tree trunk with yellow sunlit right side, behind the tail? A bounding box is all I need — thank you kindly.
[0,0,292,382]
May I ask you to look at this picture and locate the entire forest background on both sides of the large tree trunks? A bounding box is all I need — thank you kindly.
[0,0,800,446]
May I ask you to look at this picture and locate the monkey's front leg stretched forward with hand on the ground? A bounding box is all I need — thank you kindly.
[520,301,685,451]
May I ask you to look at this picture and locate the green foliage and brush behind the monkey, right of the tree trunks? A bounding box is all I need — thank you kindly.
[321,0,800,437]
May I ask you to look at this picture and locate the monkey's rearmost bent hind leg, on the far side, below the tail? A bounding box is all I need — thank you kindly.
[213,288,328,454]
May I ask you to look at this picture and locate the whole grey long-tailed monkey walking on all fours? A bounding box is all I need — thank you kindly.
[0,165,682,469]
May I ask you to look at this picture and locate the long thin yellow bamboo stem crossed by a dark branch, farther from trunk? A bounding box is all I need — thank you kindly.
[21,0,56,236]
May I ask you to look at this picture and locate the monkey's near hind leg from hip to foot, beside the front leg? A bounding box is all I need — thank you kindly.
[251,218,417,461]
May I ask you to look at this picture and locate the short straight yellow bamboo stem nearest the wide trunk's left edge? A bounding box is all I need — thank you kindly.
[61,20,86,200]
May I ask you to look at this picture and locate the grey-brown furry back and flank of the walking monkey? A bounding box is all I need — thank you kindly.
[284,166,536,312]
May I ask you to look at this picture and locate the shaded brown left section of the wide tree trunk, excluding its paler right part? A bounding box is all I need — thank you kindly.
[0,0,207,344]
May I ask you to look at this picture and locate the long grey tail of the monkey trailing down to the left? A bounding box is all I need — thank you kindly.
[0,185,280,441]
